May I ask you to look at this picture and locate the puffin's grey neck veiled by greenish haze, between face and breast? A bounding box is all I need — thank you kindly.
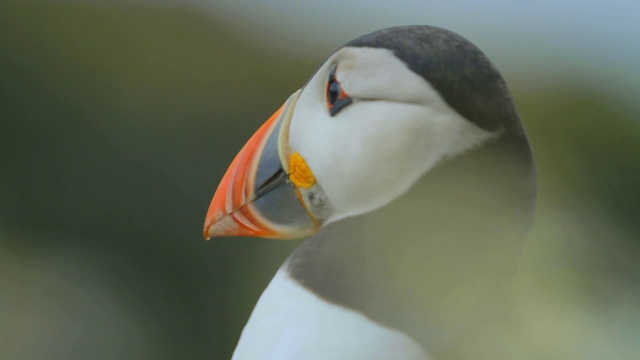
[285,133,535,357]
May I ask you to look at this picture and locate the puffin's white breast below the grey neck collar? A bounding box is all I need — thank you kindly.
[232,269,428,360]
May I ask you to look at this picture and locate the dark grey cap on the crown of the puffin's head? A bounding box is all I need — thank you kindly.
[345,25,523,133]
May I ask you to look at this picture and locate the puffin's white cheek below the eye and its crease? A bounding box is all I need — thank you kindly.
[292,101,494,222]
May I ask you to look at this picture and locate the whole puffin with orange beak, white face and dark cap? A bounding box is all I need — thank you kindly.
[204,25,536,360]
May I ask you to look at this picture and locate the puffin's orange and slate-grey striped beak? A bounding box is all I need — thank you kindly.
[204,93,318,239]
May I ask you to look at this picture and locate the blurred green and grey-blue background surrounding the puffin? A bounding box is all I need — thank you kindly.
[0,0,640,360]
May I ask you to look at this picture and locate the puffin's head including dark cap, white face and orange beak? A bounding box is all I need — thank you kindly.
[204,26,528,239]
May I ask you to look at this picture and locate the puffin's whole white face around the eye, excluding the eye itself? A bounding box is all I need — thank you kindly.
[289,47,496,222]
